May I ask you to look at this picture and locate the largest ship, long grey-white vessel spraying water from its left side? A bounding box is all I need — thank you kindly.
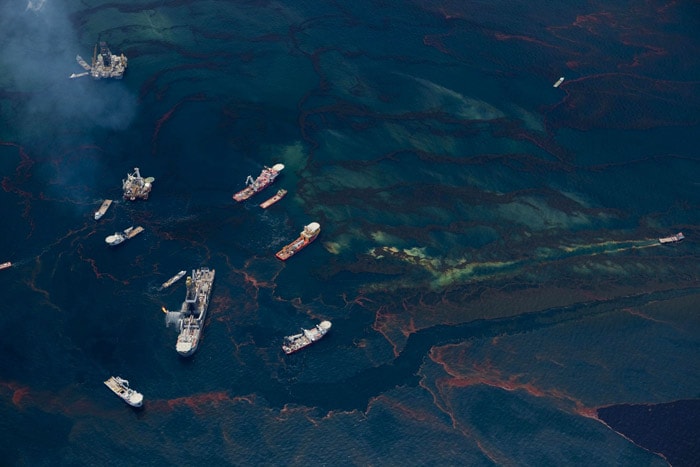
[163,268,215,357]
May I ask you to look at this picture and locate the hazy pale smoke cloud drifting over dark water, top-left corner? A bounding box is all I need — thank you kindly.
[0,0,137,136]
